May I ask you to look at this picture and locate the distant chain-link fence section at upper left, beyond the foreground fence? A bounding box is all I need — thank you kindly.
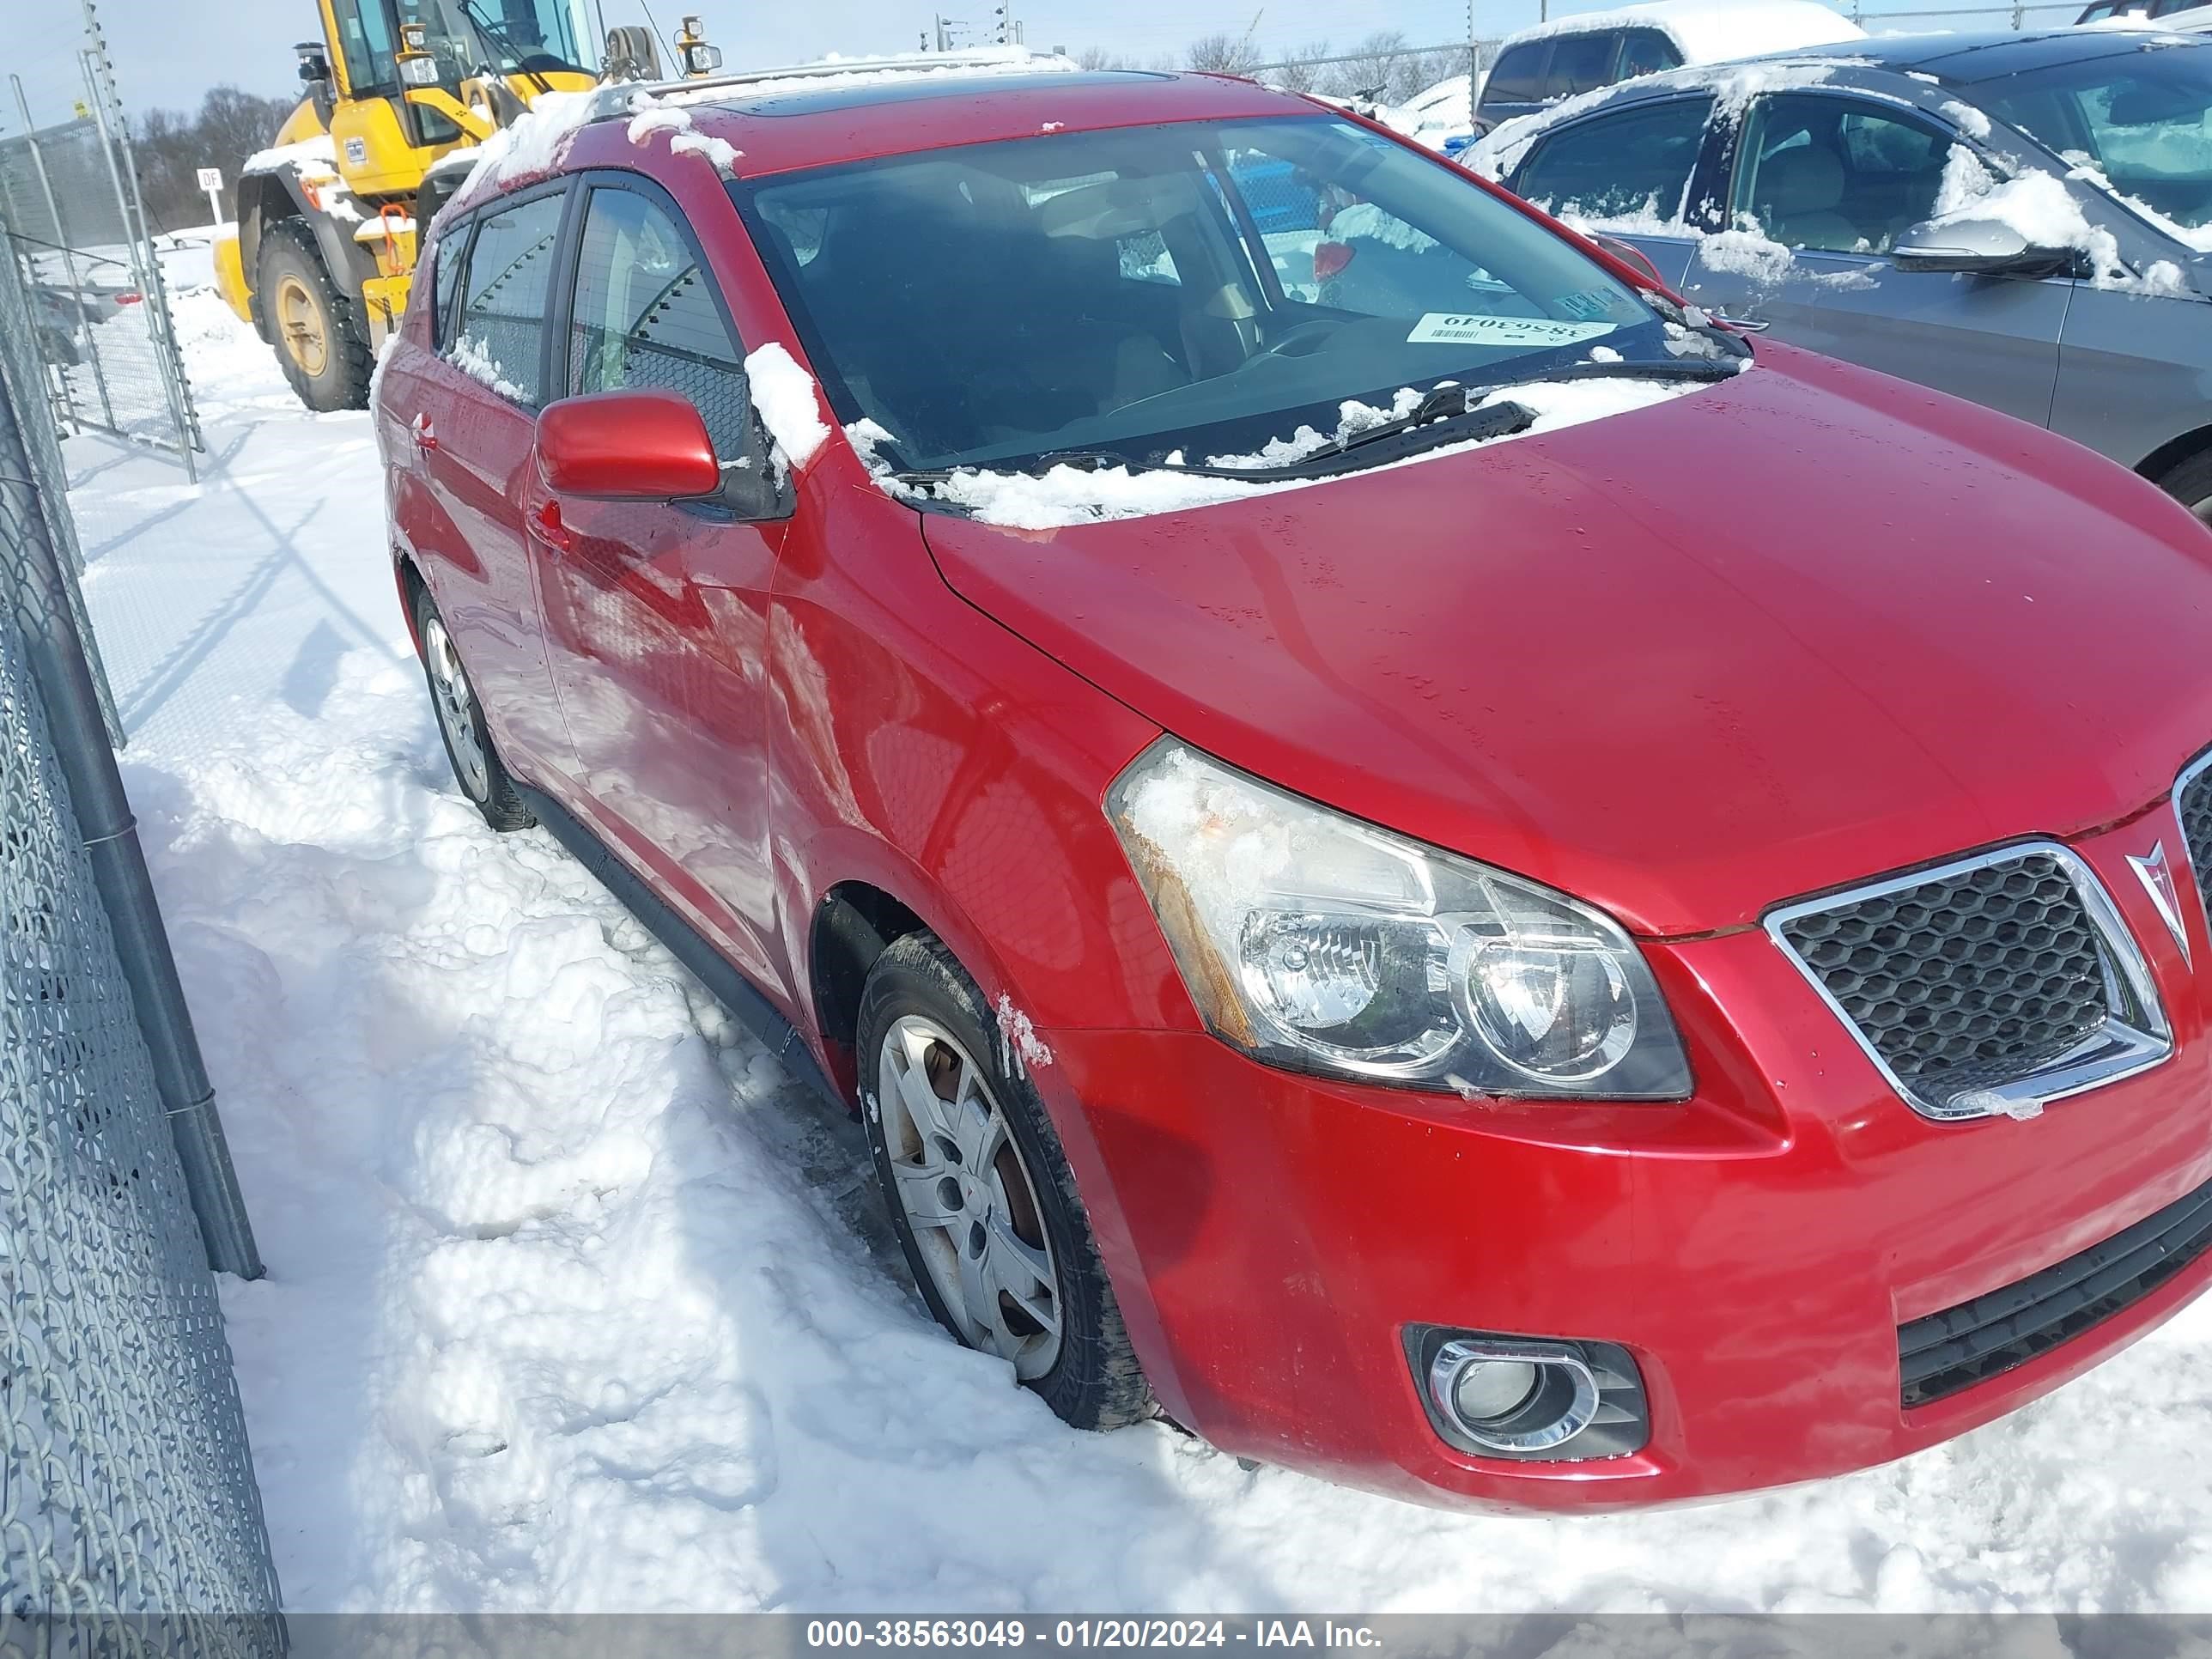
[0,51,204,473]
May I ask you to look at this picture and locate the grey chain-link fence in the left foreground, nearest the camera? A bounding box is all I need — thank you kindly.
[0,149,285,1659]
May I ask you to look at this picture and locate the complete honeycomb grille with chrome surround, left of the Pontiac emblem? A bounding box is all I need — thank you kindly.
[1767,842,2170,1117]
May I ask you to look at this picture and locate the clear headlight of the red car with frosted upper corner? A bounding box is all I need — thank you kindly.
[1106,738,1690,1099]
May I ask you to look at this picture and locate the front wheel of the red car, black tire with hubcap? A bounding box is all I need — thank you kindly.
[858,933,1152,1429]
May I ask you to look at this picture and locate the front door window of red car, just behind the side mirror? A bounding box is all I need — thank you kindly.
[568,188,750,460]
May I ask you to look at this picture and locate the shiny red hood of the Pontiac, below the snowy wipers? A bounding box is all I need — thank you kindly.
[925,345,2212,936]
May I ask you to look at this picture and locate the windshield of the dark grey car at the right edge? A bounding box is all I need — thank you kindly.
[1980,45,2212,234]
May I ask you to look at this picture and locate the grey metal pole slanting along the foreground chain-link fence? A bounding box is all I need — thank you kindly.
[0,261,264,1279]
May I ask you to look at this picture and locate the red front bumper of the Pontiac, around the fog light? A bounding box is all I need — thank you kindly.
[1037,807,2212,1509]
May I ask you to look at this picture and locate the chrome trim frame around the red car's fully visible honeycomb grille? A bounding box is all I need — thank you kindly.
[1763,845,2176,1121]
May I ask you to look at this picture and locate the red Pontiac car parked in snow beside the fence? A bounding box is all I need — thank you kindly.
[376,61,2212,1509]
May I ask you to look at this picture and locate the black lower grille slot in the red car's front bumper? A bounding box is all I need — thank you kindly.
[1898,1182,2212,1407]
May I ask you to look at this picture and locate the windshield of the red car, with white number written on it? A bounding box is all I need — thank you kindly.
[732,115,1681,469]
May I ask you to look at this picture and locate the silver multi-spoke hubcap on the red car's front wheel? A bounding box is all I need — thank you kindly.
[876,1013,1061,1382]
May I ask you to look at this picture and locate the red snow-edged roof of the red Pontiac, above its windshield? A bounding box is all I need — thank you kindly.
[623,69,1321,177]
